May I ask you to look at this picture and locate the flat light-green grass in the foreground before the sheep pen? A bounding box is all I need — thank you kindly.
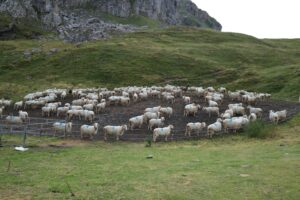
[0,115,300,200]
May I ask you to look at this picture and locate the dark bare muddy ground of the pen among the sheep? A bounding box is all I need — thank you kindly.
[3,94,300,141]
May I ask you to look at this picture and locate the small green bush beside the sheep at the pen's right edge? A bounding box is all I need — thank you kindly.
[244,119,275,139]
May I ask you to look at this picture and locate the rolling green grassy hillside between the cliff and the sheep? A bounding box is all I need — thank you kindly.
[0,28,300,100]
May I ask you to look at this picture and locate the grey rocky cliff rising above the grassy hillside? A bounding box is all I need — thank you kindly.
[0,0,222,41]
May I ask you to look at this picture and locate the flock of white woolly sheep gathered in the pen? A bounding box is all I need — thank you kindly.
[0,85,287,142]
